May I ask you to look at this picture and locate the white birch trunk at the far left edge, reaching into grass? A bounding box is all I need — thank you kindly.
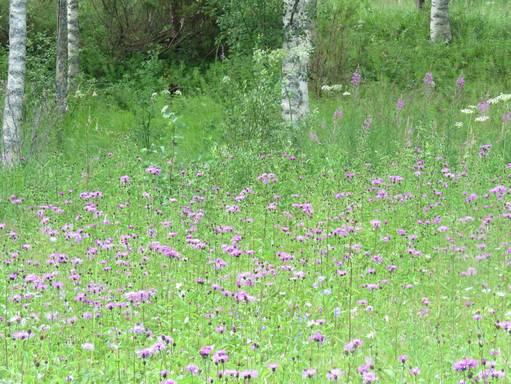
[2,0,27,167]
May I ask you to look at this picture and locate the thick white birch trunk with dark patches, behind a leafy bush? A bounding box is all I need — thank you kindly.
[282,0,316,124]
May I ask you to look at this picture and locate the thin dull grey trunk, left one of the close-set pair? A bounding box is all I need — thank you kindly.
[55,0,67,114]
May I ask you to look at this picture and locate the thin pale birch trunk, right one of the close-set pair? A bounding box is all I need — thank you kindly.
[67,0,80,93]
